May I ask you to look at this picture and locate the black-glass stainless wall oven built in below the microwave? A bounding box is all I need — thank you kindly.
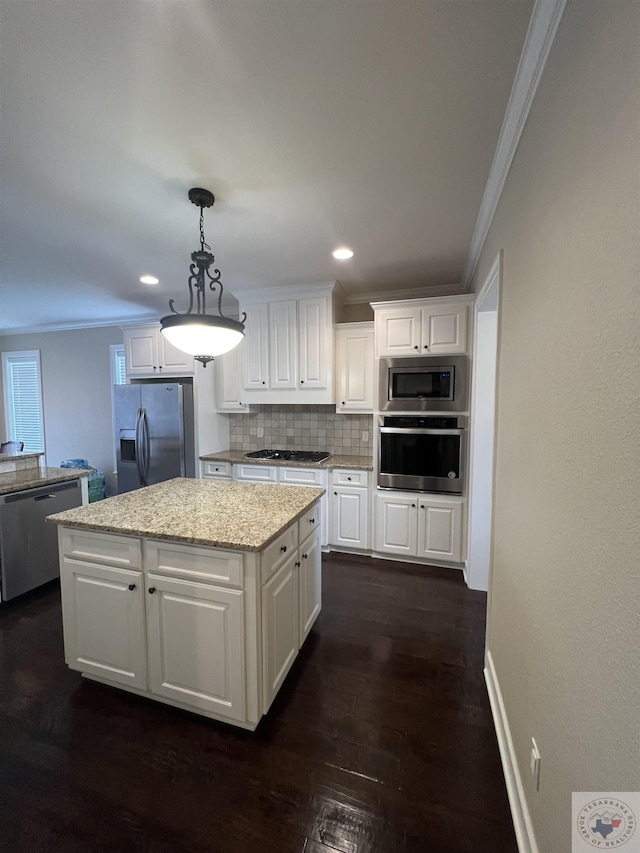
[378,415,467,495]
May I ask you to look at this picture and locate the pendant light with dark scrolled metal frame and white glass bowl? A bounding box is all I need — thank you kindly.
[160,187,247,367]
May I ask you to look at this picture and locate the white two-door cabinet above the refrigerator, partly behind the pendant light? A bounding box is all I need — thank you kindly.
[123,323,194,377]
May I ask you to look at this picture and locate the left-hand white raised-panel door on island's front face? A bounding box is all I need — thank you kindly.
[61,558,147,689]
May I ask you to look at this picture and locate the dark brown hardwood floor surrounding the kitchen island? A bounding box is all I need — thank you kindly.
[0,554,517,853]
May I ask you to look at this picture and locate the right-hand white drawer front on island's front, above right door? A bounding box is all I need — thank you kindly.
[145,541,243,587]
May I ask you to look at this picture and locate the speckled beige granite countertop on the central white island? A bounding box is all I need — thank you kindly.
[47,477,324,551]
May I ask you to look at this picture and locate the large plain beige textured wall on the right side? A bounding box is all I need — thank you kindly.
[474,0,640,853]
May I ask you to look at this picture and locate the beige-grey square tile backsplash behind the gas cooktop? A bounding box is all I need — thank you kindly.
[229,406,373,456]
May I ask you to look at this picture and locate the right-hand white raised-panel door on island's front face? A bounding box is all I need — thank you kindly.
[145,573,245,721]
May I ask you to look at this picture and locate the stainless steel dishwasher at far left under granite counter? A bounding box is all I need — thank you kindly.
[0,480,82,601]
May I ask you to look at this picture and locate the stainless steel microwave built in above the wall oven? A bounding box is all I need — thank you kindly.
[378,355,469,412]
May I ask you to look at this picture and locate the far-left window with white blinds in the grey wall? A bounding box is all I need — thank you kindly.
[2,350,44,453]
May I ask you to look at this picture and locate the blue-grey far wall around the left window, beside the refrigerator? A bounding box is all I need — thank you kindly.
[0,326,122,489]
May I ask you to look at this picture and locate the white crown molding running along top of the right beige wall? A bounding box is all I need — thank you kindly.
[462,0,566,291]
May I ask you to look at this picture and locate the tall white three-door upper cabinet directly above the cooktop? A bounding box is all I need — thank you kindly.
[238,282,336,404]
